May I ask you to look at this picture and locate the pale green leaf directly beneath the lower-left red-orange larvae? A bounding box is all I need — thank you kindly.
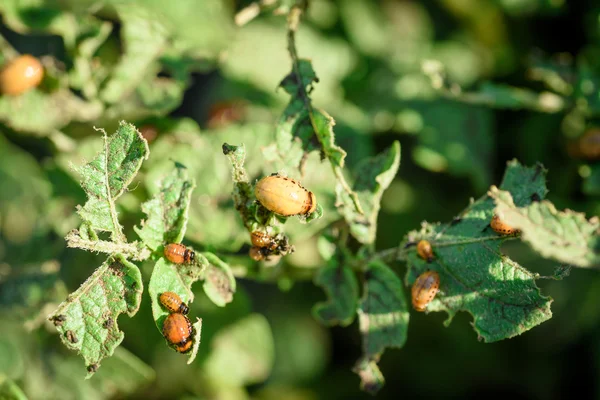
[148,254,208,364]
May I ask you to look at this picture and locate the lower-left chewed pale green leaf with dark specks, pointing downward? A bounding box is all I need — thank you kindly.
[49,255,143,378]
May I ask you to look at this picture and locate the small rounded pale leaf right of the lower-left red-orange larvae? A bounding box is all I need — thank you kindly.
[200,252,235,307]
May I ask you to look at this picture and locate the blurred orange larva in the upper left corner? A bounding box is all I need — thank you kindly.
[0,54,44,96]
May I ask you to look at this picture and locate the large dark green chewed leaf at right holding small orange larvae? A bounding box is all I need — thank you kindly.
[405,160,552,342]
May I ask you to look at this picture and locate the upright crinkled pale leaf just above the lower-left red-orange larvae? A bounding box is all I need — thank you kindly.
[134,164,195,251]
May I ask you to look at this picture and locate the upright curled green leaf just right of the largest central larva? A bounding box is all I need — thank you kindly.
[336,141,400,244]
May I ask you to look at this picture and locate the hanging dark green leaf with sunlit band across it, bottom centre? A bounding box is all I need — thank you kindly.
[358,261,409,360]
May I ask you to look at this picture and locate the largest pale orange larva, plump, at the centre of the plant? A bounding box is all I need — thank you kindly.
[254,175,317,217]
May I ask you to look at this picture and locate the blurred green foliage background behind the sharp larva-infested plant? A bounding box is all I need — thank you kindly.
[0,0,600,400]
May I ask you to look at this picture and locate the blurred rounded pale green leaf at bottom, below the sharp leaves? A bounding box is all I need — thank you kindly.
[204,314,275,387]
